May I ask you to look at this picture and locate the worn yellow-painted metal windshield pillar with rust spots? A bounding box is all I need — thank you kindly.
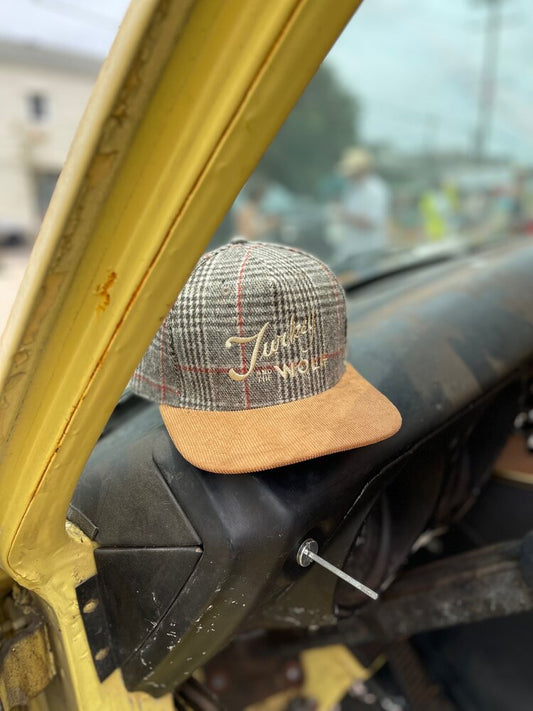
[0,0,359,711]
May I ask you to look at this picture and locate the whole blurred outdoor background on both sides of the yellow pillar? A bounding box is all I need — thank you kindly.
[0,0,533,338]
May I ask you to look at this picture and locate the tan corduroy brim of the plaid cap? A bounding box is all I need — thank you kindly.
[159,364,402,474]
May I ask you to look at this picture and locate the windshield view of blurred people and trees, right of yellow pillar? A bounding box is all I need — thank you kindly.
[207,0,533,282]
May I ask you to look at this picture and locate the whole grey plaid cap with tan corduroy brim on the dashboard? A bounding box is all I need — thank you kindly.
[130,240,401,474]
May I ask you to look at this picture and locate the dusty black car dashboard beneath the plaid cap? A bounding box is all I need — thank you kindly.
[69,240,533,696]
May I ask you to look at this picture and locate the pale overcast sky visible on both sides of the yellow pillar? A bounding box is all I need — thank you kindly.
[0,0,533,163]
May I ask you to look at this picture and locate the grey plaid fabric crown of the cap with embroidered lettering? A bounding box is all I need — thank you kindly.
[130,242,346,411]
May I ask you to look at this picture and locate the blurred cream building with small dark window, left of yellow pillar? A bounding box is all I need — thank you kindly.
[0,40,101,242]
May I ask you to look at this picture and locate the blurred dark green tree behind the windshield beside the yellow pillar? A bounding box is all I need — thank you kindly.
[258,64,359,194]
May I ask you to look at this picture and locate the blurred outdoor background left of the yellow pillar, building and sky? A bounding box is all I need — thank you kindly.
[0,0,128,334]
